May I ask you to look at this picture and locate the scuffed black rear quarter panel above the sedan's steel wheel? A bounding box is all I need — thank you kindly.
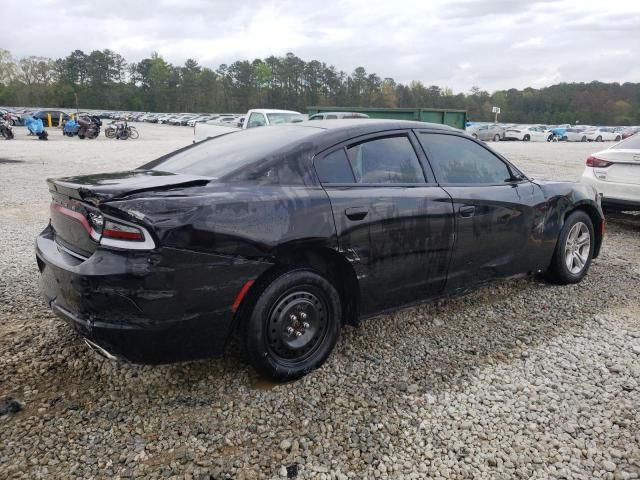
[102,183,337,261]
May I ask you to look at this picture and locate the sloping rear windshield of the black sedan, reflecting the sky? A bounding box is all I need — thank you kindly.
[146,125,321,179]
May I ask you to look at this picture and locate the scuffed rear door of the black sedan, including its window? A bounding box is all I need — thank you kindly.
[314,131,454,314]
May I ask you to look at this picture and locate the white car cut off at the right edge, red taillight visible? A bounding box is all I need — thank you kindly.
[580,134,640,210]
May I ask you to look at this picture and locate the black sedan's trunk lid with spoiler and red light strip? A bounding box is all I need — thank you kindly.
[47,170,210,258]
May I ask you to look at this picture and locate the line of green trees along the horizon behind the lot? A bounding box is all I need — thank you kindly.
[0,49,640,125]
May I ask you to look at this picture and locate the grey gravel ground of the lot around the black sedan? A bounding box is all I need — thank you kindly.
[0,124,640,479]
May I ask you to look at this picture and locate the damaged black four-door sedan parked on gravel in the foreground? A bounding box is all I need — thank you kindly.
[36,119,605,380]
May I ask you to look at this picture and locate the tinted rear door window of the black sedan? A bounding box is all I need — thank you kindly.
[347,135,425,184]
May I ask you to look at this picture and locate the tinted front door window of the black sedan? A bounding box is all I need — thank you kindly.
[418,133,511,185]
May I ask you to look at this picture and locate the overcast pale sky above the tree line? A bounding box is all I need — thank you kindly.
[0,0,640,92]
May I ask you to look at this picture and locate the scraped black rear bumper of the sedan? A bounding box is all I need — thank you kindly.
[36,227,270,364]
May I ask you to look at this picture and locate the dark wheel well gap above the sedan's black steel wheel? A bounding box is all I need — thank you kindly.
[265,247,360,325]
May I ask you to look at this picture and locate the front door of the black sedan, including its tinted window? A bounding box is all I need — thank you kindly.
[418,132,544,291]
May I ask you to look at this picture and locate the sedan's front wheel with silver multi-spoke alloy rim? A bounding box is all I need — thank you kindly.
[546,210,595,285]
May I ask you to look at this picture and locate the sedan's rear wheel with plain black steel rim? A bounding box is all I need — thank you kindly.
[241,268,342,381]
